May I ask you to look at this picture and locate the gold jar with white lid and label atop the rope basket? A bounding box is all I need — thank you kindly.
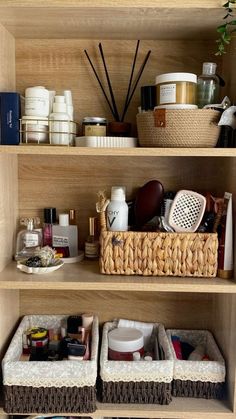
[155,73,197,109]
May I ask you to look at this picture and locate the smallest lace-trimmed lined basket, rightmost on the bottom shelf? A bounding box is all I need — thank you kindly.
[166,330,225,399]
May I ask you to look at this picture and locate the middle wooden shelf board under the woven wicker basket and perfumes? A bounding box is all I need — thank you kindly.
[0,261,236,293]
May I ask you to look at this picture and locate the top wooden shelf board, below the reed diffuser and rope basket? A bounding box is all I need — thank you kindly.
[0,145,236,157]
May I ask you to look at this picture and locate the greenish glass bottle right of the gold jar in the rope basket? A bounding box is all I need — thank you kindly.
[197,63,220,108]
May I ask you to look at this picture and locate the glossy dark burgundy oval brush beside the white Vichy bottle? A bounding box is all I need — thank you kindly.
[134,180,164,227]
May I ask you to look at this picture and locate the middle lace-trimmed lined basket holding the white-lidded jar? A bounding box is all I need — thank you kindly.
[100,322,173,404]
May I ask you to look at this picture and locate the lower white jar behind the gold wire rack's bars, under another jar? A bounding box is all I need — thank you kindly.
[21,116,49,144]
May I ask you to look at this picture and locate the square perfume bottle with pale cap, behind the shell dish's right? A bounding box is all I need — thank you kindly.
[52,214,78,257]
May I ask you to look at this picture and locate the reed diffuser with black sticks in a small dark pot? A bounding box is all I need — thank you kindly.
[84,40,151,137]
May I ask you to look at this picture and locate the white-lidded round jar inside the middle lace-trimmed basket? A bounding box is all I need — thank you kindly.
[108,327,144,361]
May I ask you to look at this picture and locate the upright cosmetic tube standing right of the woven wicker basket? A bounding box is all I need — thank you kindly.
[218,192,233,279]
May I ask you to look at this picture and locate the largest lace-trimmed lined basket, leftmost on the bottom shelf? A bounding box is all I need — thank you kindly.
[2,315,98,414]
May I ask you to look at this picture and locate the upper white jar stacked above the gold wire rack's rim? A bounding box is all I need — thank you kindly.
[25,86,49,117]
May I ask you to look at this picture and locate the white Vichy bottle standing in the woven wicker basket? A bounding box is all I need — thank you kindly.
[107,186,128,231]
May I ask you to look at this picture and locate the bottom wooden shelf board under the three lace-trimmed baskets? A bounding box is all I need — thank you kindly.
[0,397,235,419]
